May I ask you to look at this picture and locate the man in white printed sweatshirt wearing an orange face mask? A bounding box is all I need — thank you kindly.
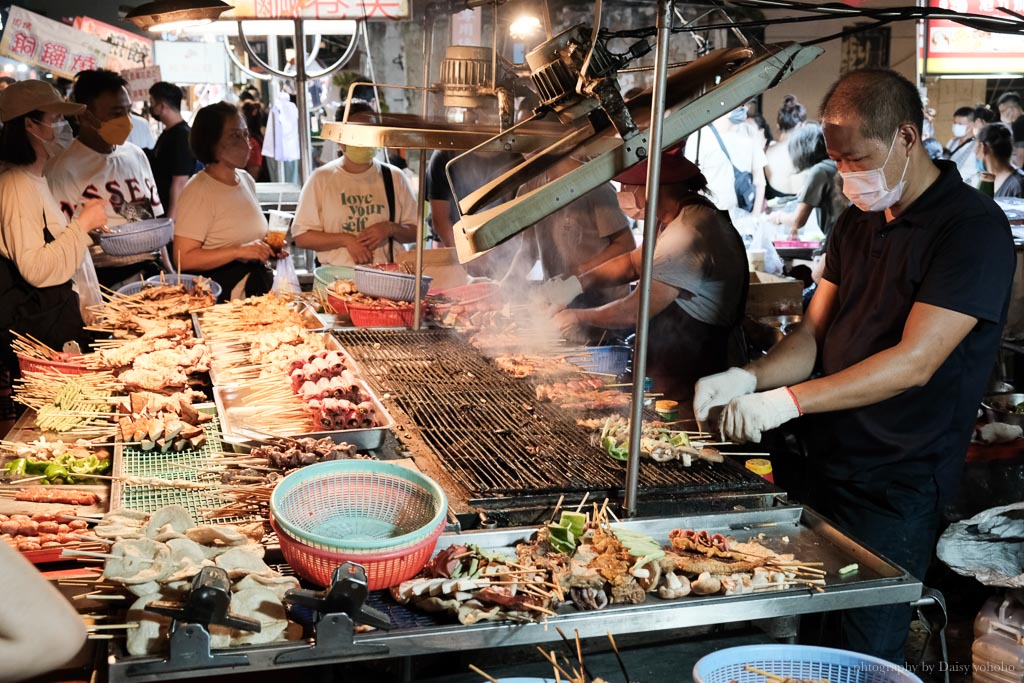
[43,69,164,287]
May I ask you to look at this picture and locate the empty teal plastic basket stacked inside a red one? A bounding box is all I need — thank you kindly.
[270,460,447,553]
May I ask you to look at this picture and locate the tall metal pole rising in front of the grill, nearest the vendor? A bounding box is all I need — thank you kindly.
[624,0,673,516]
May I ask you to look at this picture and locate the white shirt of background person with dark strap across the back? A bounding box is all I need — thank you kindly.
[684,106,768,214]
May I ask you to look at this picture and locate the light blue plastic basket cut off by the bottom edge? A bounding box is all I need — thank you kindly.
[693,645,922,683]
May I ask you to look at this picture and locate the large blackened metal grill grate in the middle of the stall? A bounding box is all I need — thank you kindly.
[338,330,763,497]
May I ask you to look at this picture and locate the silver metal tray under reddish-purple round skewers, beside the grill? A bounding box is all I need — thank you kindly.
[213,380,395,451]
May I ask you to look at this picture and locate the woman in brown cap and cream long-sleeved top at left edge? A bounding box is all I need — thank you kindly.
[0,81,106,433]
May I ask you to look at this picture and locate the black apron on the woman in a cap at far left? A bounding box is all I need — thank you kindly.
[0,214,90,369]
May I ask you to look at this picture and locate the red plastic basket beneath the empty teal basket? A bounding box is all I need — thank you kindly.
[270,515,446,591]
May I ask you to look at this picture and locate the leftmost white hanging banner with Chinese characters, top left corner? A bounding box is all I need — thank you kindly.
[0,6,111,78]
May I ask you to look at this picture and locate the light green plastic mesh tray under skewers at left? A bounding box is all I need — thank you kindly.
[111,403,260,524]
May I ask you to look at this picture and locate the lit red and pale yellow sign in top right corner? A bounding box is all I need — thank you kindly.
[922,0,1024,76]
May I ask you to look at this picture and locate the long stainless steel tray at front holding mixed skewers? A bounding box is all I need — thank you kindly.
[103,506,922,683]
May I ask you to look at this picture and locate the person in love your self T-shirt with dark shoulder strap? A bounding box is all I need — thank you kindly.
[292,103,418,265]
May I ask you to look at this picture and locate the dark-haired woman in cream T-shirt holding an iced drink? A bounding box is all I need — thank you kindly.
[174,102,273,299]
